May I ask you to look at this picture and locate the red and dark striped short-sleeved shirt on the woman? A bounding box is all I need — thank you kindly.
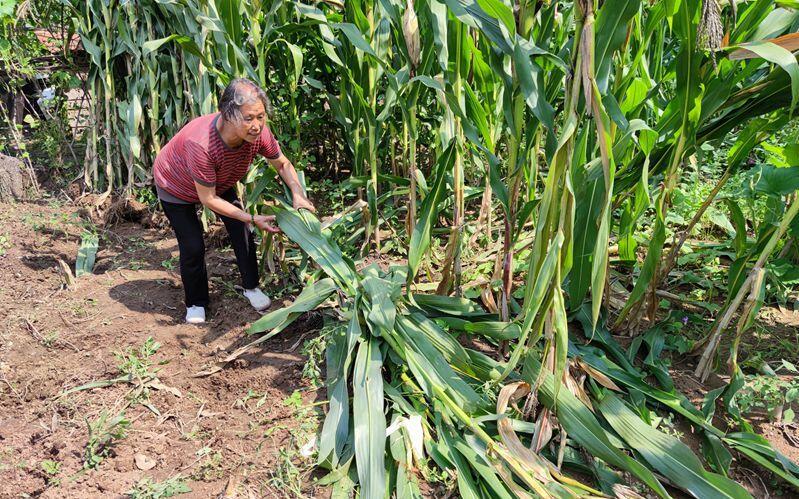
[153,113,281,203]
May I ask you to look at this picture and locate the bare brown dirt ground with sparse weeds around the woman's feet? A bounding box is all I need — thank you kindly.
[0,198,324,498]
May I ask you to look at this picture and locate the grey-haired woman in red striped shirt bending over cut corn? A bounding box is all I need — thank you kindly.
[153,78,315,324]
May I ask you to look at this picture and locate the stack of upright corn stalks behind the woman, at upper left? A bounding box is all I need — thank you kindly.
[69,1,256,196]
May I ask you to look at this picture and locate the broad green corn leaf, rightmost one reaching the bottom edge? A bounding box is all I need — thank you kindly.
[599,393,752,499]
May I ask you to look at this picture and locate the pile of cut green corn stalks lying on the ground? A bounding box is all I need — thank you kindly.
[250,201,799,497]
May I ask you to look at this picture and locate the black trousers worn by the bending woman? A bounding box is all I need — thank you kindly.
[161,188,258,307]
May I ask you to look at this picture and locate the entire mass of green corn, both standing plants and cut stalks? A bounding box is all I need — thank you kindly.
[62,0,799,498]
